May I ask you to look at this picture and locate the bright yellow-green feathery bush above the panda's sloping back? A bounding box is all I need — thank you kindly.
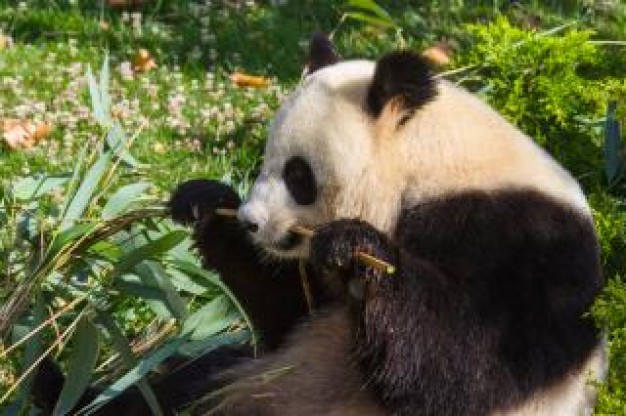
[459,17,626,180]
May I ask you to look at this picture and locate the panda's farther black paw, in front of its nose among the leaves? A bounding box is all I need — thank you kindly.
[167,179,241,225]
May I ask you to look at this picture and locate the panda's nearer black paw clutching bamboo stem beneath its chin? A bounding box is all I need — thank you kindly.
[310,220,396,284]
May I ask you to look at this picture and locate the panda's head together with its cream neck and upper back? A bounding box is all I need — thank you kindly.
[239,37,588,258]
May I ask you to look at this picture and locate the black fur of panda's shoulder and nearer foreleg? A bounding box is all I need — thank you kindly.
[312,190,602,416]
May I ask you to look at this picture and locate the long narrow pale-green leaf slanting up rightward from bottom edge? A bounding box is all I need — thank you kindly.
[79,338,185,414]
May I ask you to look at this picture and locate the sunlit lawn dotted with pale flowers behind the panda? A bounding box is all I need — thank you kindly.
[0,0,614,189]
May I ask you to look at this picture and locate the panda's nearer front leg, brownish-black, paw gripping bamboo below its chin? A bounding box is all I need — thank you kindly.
[310,220,480,416]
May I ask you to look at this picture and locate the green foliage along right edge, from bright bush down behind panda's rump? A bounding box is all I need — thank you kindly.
[457,17,626,415]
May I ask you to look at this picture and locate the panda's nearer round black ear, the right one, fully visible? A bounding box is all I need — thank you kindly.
[367,51,437,117]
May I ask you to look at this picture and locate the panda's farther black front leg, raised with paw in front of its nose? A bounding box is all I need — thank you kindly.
[169,179,308,350]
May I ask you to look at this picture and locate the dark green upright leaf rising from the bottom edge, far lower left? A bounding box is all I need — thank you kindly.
[53,315,98,415]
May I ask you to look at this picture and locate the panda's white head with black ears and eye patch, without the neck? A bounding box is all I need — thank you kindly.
[239,35,435,257]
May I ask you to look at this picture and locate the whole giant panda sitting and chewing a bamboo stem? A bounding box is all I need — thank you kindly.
[170,36,605,416]
